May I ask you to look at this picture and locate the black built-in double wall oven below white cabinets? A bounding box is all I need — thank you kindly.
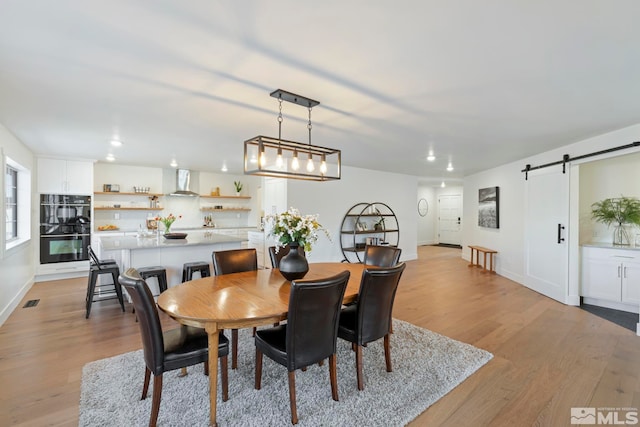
[40,194,91,264]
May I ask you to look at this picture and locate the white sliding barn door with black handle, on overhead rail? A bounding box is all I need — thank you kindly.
[525,166,570,304]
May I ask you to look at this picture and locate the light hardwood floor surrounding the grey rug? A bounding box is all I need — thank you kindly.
[0,246,640,427]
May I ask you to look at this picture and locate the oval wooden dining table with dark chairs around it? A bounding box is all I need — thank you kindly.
[158,263,366,426]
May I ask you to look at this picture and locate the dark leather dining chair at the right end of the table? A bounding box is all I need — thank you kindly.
[338,263,406,390]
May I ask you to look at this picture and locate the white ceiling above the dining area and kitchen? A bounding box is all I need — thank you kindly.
[0,0,640,182]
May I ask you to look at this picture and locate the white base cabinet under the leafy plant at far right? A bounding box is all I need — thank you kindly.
[582,246,640,313]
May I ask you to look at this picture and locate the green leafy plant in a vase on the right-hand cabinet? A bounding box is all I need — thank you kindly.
[591,196,640,246]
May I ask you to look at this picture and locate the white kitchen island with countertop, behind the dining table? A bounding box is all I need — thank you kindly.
[99,231,247,294]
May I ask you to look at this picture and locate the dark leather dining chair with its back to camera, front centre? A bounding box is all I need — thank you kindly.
[255,271,349,424]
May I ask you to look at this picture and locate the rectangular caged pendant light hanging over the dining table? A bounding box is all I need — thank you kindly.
[244,89,342,181]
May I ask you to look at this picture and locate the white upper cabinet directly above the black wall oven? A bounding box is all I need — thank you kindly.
[38,158,93,194]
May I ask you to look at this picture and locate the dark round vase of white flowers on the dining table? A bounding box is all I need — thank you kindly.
[266,208,329,280]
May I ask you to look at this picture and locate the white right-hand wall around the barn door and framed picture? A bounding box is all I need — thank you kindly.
[462,121,640,288]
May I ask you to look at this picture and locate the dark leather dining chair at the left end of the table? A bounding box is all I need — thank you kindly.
[118,268,229,427]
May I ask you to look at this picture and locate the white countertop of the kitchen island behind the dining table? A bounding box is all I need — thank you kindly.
[99,233,246,251]
